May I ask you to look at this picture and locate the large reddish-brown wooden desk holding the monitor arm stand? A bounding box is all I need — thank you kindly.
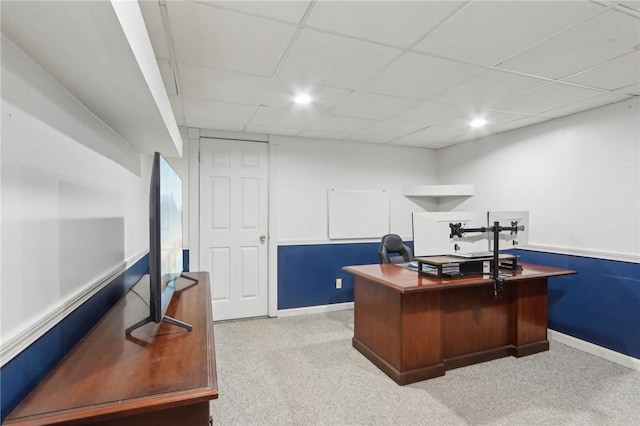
[343,263,576,385]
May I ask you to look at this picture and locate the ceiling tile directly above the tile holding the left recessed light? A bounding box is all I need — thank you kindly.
[278,29,401,89]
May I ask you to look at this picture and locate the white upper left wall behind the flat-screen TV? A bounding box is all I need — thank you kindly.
[0,37,151,350]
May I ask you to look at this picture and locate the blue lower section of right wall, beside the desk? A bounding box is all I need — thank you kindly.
[514,250,640,359]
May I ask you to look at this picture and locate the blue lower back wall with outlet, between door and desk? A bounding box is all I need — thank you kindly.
[278,241,413,309]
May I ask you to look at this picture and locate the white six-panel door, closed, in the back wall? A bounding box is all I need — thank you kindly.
[199,138,269,321]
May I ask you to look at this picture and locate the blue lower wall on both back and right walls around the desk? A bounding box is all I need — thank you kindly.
[278,242,640,359]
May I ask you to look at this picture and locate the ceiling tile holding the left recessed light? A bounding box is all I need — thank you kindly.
[262,80,350,113]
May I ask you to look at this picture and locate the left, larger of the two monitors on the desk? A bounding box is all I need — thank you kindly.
[412,211,489,257]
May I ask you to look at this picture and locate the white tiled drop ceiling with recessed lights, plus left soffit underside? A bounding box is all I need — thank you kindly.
[2,0,640,152]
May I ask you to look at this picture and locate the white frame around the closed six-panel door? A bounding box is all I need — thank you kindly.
[187,128,278,317]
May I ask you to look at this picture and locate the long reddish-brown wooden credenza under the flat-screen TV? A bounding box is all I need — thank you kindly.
[4,272,218,426]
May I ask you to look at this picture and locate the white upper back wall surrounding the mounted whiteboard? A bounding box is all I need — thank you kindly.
[270,136,438,244]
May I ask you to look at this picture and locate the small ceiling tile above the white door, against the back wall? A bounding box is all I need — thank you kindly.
[183,97,255,131]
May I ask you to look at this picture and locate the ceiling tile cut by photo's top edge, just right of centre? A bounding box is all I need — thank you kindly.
[307,1,464,48]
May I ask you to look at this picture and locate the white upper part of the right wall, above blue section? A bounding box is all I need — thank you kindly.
[438,99,640,260]
